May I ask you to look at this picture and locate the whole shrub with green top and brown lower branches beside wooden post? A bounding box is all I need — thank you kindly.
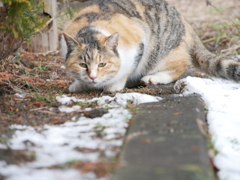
[0,0,45,60]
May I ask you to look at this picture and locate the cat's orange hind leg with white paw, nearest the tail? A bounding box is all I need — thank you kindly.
[141,43,191,85]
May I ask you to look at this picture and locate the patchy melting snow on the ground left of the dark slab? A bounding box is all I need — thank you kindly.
[0,93,161,180]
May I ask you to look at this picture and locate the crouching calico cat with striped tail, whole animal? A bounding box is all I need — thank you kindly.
[61,0,240,92]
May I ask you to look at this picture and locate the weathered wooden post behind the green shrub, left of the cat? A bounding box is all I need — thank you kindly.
[24,0,58,53]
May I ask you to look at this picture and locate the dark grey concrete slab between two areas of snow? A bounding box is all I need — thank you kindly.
[112,96,214,180]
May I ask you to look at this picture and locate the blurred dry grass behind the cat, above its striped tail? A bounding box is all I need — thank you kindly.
[167,0,240,56]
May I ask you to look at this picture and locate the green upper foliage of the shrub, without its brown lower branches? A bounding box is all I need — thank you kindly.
[0,0,46,40]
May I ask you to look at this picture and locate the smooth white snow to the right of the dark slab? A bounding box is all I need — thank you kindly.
[175,77,240,180]
